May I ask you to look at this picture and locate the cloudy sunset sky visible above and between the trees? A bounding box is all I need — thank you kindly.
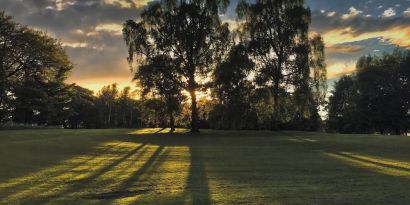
[0,0,410,91]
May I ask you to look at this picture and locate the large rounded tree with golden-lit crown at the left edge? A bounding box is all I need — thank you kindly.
[0,12,73,124]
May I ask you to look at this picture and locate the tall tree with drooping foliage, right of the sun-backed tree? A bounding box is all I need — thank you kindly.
[237,0,326,126]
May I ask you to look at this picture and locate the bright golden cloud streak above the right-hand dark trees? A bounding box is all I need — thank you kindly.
[323,27,410,47]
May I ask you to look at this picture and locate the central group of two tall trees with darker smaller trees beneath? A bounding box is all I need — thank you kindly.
[123,0,326,132]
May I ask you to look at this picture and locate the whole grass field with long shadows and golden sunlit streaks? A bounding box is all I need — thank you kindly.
[0,129,410,205]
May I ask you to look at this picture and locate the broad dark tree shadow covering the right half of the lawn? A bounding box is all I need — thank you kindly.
[122,132,410,204]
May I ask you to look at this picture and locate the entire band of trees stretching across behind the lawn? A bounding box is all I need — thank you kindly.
[0,0,410,134]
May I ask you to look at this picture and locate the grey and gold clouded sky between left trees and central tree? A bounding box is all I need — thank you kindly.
[0,0,149,89]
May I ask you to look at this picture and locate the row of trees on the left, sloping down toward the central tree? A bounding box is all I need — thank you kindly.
[0,12,175,128]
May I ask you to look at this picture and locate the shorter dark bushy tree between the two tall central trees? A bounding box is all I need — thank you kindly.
[209,44,256,129]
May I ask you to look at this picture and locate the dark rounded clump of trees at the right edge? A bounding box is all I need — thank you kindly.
[327,51,410,135]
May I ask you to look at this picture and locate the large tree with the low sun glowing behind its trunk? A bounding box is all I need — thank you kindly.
[124,0,229,132]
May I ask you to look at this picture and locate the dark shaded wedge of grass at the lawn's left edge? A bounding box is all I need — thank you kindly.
[0,129,131,186]
